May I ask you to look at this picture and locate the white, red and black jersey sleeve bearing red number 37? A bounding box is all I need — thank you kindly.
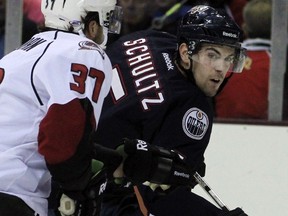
[34,38,112,191]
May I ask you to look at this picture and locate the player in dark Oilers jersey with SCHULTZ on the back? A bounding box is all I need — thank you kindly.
[95,6,246,216]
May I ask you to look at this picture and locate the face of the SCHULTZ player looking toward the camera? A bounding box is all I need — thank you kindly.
[192,44,235,97]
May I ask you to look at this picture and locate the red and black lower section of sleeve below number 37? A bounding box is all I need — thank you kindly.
[38,99,94,190]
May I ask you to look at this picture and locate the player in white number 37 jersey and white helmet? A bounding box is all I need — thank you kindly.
[0,0,120,216]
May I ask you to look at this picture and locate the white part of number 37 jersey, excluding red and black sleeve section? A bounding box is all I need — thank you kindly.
[0,31,112,216]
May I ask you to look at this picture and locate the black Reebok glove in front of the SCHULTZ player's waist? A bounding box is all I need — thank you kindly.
[117,138,195,186]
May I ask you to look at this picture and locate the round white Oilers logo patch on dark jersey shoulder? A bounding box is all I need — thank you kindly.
[182,107,209,140]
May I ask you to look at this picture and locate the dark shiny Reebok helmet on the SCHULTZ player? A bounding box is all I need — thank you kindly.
[177,5,246,72]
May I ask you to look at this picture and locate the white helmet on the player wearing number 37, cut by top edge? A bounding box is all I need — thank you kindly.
[41,0,121,33]
